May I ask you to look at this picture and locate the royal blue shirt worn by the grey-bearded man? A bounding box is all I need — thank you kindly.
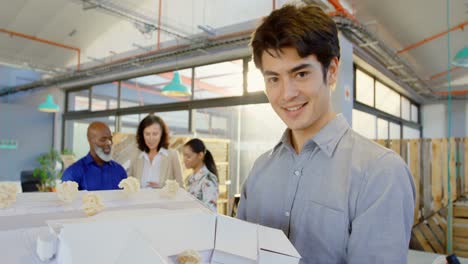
[62,153,127,191]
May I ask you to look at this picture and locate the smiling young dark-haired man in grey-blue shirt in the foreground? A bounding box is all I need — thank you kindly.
[238,3,415,264]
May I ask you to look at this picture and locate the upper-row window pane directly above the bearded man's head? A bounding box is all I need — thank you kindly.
[91,82,119,111]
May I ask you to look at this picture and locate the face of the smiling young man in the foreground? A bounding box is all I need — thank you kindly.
[262,48,338,132]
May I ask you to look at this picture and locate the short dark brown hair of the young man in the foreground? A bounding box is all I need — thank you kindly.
[250,5,340,80]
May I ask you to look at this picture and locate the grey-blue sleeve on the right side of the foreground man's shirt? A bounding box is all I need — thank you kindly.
[347,152,415,264]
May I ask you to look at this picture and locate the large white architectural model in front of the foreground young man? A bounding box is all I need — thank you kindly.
[49,209,300,264]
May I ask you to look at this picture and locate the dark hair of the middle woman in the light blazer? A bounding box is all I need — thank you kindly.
[136,114,169,153]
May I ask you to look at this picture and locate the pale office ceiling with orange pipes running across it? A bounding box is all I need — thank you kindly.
[0,0,468,100]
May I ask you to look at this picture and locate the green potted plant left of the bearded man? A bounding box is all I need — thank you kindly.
[33,149,62,192]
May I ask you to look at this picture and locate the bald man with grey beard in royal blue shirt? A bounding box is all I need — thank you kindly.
[62,122,127,191]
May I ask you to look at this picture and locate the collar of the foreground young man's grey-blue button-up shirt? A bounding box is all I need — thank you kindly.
[272,114,349,157]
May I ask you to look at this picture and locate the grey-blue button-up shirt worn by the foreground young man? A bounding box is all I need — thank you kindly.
[238,115,415,264]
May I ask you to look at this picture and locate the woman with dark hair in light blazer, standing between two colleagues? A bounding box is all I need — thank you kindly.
[128,114,184,188]
